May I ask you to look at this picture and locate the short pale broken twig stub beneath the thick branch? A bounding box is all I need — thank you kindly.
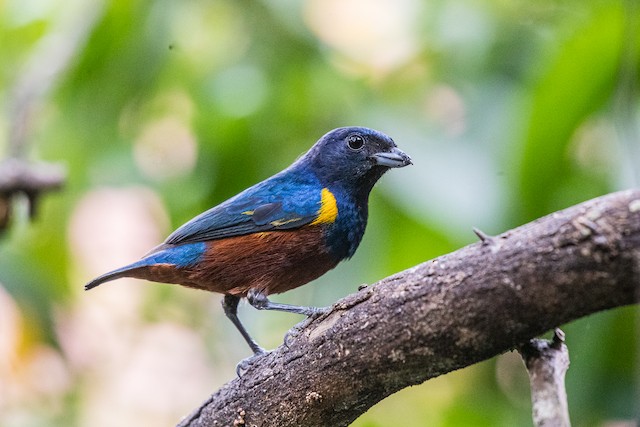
[518,328,571,427]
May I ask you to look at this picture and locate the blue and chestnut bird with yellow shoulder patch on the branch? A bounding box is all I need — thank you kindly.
[85,127,411,354]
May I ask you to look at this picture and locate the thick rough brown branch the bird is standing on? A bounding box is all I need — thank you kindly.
[179,190,640,427]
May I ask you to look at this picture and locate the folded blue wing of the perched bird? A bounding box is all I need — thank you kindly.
[165,177,322,244]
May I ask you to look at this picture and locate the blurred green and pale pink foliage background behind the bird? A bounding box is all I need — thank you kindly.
[0,0,640,427]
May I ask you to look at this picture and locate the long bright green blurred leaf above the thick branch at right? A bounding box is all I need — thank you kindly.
[518,2,625,220]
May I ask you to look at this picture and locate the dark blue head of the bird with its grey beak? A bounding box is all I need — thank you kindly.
[297,127,411,198]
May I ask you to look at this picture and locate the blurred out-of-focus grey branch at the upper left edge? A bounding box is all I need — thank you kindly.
[0,0,104,233]
